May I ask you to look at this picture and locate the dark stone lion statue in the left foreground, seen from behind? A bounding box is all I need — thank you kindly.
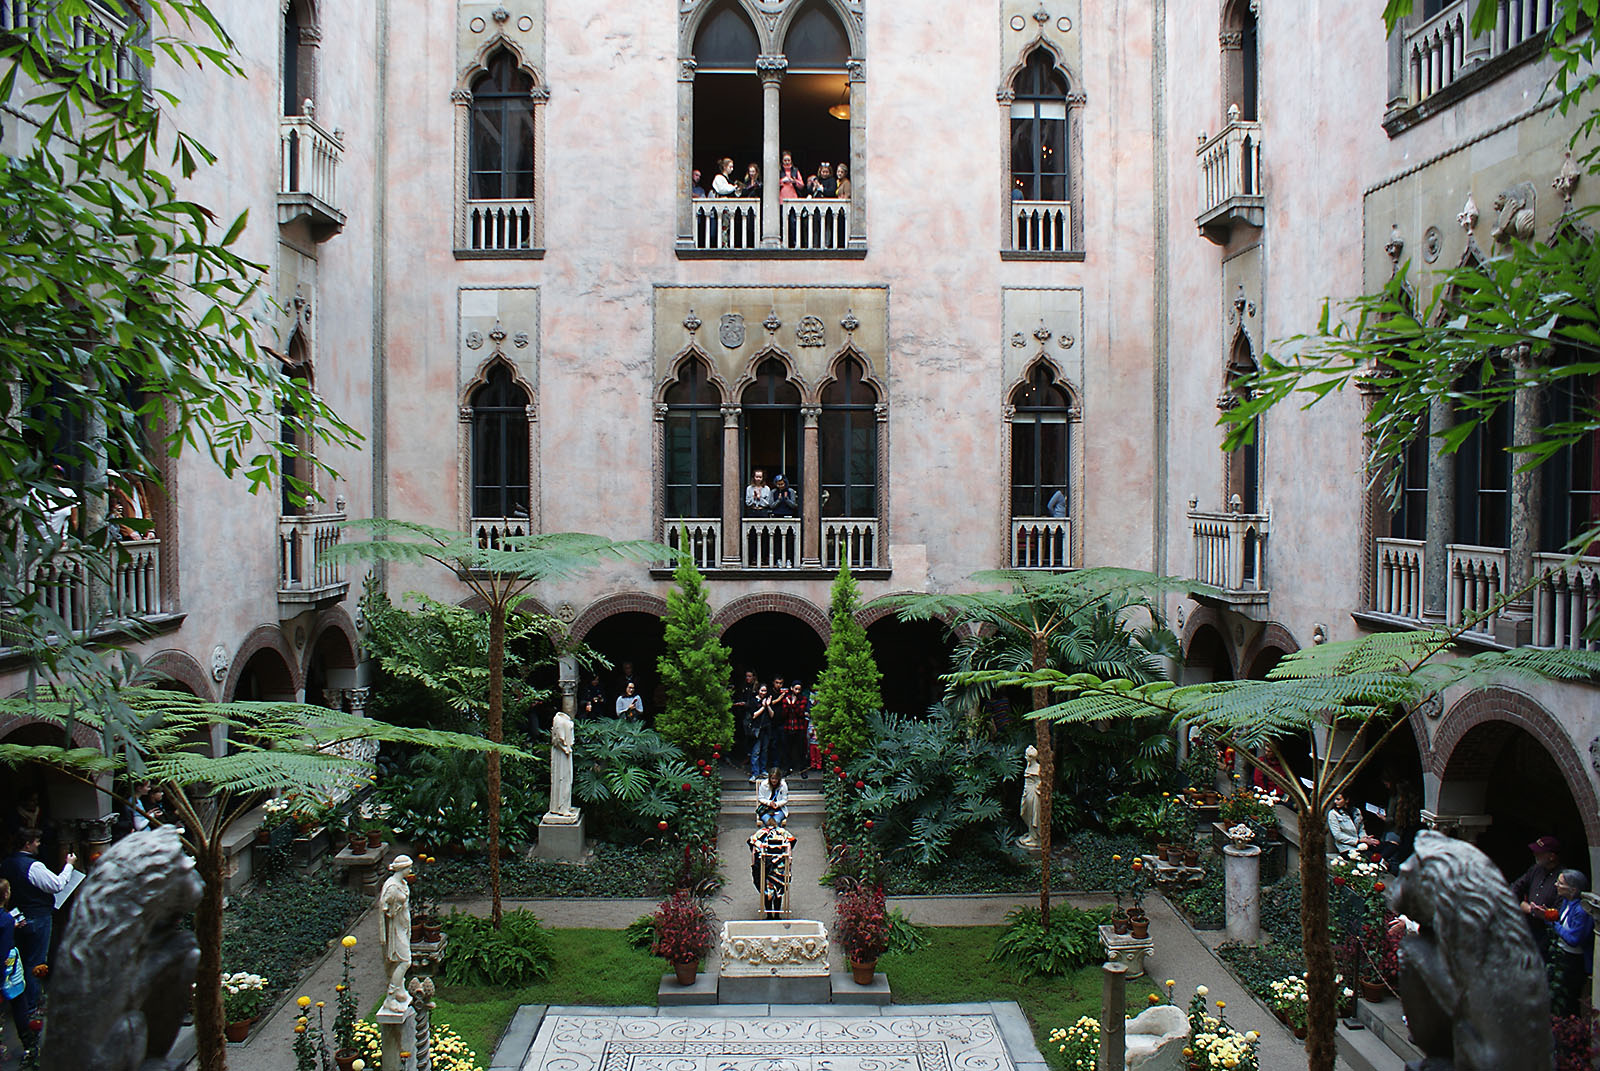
[38,826,200,1071]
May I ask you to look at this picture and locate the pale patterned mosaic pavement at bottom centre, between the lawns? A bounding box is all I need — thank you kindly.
[522,1005,1038,1071]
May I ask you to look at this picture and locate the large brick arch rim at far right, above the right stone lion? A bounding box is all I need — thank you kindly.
[1424,687,1600,845]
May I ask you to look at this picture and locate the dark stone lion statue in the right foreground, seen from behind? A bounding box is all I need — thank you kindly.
[1389,829,1554,1071]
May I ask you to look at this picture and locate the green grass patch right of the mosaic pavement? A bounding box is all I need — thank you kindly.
[878,925,1155,1069]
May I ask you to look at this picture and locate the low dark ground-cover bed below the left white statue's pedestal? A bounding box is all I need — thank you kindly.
[424,844,672,900]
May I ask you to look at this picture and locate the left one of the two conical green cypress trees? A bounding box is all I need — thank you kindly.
[656,533,733,756]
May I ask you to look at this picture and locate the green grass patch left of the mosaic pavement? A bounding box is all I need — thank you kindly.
[434,930,667,1066]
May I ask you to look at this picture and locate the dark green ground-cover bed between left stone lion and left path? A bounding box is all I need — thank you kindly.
[222,848,370,1007]
